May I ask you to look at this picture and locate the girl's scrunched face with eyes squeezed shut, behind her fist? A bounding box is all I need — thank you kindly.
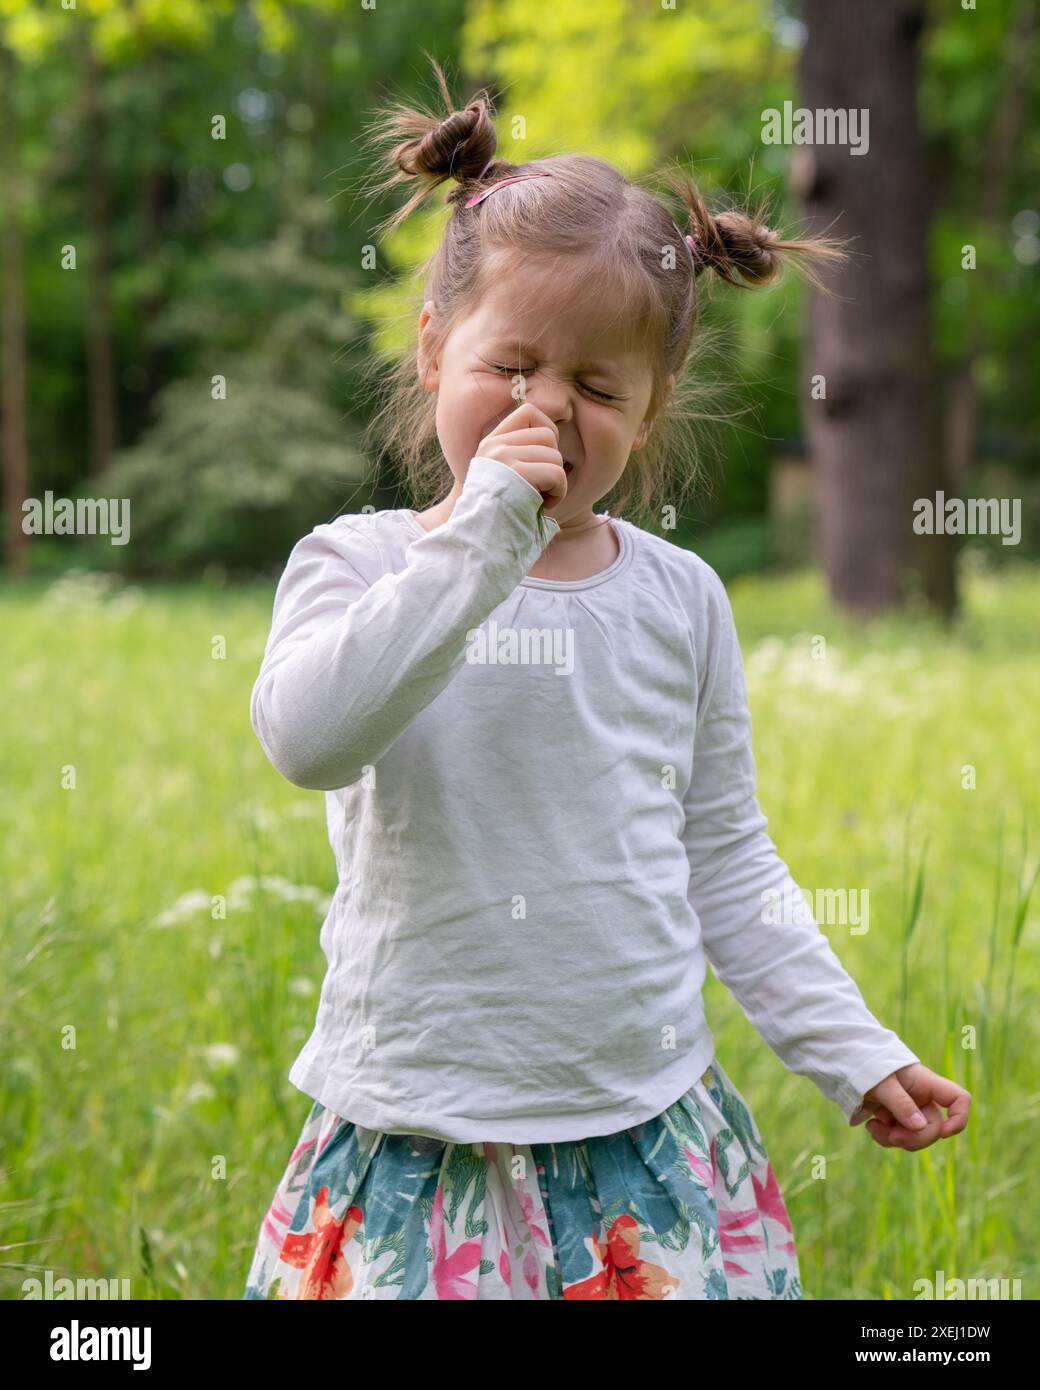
[419,254,667,530]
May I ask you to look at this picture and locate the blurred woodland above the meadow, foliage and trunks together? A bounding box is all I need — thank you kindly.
[0,0,1040,607]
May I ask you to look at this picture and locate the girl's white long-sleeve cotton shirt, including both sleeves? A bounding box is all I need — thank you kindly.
[250,456,919,1143]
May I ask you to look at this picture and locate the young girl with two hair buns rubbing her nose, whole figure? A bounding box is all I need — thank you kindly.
[245,70,970,1298]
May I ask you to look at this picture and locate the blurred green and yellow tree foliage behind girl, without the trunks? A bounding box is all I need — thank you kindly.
[0,0,1040,573]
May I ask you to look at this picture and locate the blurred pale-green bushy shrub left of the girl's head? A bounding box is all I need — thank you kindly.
[94,200,367,574]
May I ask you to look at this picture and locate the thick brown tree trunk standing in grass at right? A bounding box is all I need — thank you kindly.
[797,0,955,614]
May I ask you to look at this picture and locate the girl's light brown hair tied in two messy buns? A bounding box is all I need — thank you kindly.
[358,54,844,521]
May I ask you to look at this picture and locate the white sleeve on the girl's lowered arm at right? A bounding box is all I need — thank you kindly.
[683,566,920,1125]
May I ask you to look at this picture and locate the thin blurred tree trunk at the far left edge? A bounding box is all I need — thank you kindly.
[0,44,29,580]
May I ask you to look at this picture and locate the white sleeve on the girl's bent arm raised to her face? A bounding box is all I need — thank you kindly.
[249,455,559,791]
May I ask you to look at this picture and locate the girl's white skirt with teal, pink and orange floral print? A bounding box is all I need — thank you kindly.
[243,1059,802,1298]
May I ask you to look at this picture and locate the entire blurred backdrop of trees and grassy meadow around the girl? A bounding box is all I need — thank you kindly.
[0,0,1040,1298]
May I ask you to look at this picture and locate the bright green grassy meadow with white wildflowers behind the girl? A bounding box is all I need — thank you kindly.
[0,558,1040,1298]
